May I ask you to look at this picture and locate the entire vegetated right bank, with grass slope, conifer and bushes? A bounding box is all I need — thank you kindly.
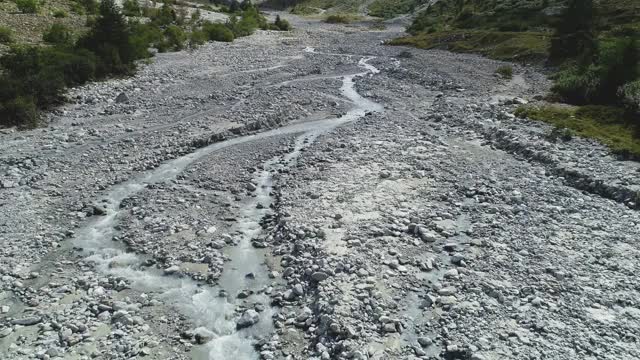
[390,0,640,157]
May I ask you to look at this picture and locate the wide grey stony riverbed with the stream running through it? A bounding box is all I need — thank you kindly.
[0,15,640,360]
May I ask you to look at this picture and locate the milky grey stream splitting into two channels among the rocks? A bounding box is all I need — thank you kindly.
[74,58,382,359]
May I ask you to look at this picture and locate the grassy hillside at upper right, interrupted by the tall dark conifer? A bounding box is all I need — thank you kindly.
[391,0,640,61]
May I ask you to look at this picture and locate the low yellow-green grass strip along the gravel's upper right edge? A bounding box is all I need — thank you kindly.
[388,30,549,61]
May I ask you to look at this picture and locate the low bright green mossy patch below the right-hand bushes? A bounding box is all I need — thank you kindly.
[516,105,640,160]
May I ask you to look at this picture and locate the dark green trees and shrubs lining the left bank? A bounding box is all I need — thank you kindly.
[0,0,276,128]
